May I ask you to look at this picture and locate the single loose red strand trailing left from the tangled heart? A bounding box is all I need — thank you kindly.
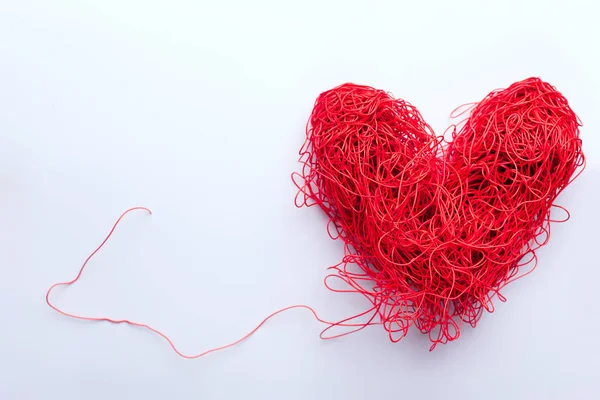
[46,207,371,359]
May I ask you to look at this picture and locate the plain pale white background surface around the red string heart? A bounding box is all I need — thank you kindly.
[0,0,600,400]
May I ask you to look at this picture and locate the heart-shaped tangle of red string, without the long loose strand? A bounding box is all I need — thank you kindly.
[293,78,585,350]
